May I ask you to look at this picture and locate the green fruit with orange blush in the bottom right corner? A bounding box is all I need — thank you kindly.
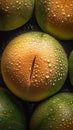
[30,92,73,130]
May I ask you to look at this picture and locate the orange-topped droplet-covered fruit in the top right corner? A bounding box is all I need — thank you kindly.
[35,0,73,40]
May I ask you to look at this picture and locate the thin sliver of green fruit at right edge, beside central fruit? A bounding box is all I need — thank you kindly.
[69,51,73,85]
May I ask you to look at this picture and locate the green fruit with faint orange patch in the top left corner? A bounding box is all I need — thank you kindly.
[0,0,34,31]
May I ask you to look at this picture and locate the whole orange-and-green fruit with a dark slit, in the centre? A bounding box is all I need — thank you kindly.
[1,32,68,101]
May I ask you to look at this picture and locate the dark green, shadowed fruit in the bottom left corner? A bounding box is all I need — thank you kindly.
[0,88,26,130]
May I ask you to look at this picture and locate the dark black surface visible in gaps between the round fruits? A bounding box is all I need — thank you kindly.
[0,15,73,129]
